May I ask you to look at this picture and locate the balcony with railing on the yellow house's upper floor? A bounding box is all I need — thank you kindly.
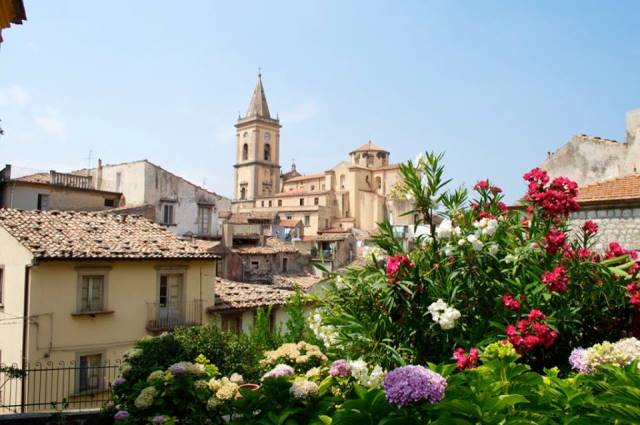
[146,300,204,333]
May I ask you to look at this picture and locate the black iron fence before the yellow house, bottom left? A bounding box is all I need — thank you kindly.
[0,360,120,415]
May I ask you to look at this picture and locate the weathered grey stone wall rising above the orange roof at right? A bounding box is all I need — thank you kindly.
[540,109,640,186]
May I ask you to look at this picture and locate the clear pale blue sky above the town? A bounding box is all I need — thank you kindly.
[0,0,640,200]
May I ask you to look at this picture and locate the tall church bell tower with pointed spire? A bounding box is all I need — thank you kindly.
[233,74,281,212]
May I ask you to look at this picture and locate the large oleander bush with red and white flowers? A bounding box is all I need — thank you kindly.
[314,153,640,371]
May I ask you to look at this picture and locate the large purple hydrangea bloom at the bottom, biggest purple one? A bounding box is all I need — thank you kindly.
[383,365,447,407]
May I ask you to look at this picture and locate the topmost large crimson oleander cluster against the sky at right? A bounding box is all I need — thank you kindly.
[523,168,579,217]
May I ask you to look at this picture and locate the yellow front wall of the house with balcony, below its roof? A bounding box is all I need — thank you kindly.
[29,261,215,362]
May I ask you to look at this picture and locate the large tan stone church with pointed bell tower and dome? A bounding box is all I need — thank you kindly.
[233,75,414,237]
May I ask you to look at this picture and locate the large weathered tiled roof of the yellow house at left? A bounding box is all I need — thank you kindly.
[0,209,215,259]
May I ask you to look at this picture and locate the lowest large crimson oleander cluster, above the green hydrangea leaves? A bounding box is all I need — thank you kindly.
[505,309,558,354]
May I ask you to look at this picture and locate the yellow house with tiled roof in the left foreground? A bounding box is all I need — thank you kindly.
[0,209,216,408]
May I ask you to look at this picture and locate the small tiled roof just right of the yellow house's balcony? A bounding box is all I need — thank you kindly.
[207,278,293,313]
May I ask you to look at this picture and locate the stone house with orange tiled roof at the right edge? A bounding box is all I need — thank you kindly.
[571,174,640,252]
